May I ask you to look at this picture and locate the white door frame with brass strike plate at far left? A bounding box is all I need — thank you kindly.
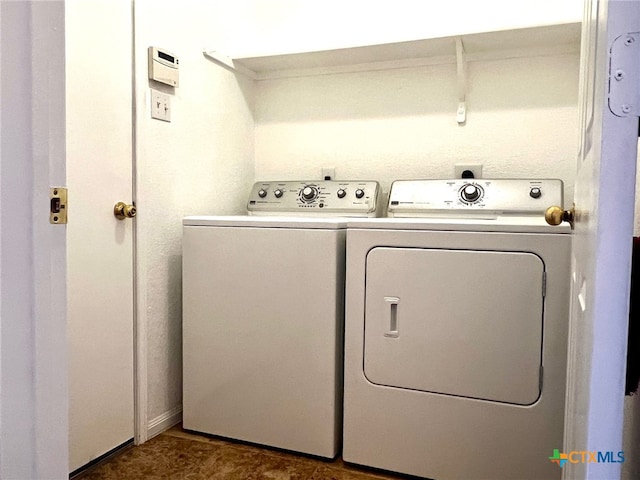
[0,1,68,479]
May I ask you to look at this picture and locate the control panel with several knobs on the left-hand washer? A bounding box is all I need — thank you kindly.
[247,180,381,217]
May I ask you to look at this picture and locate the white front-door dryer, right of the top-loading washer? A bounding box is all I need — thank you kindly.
[343,180,570,480]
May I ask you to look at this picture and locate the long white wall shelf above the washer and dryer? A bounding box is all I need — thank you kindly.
[205,22,581,80]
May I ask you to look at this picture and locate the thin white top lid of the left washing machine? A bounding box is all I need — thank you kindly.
[182,215,347,229]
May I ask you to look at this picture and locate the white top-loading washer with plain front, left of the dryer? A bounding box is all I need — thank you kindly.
[183,181,379,458]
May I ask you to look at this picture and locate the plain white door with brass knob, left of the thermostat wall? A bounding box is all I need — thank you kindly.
[66,0,134,471]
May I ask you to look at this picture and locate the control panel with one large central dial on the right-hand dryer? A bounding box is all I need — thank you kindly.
[387,178,563,217]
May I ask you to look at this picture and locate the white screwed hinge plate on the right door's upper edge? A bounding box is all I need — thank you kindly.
[609,32,640,117]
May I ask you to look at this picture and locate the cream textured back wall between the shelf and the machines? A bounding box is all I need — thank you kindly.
[255,53,579,200]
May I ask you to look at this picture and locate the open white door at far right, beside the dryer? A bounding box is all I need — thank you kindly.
[564,0,640,480]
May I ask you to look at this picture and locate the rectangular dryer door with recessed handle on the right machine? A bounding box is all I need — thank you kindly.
[364,247,544,405]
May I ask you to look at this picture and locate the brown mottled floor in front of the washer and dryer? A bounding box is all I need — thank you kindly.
[74,426,411,480]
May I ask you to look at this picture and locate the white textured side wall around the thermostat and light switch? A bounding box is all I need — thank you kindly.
[135,0,254,434]
